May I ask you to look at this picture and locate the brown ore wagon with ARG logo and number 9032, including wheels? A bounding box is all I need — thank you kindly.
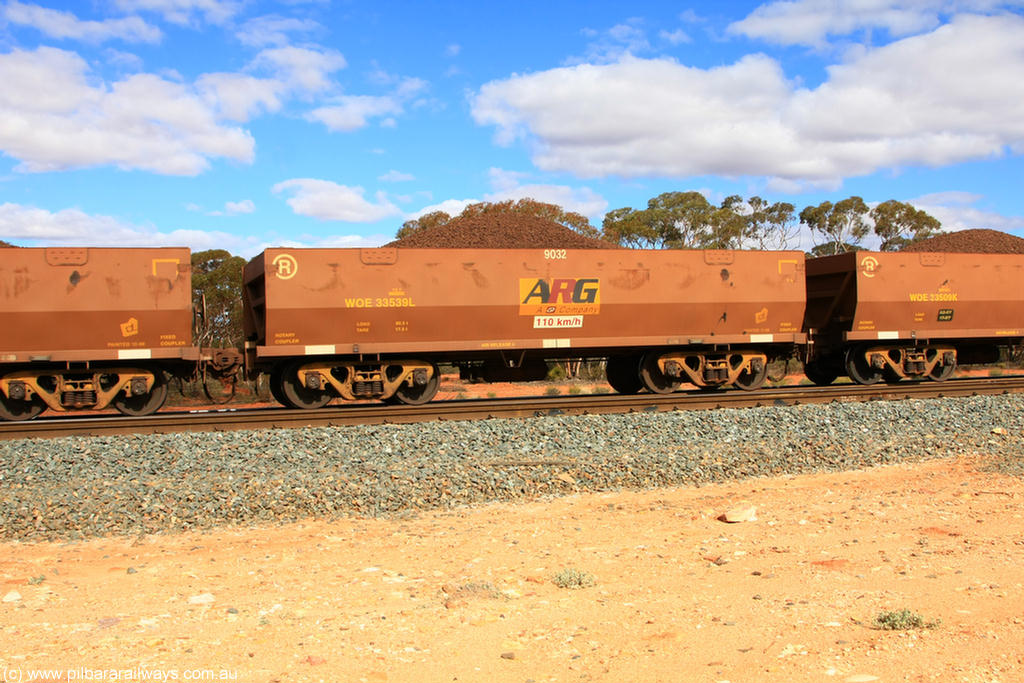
[244,249,805,408]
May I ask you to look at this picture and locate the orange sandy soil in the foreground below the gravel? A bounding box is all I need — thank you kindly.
[0,450,1024,683]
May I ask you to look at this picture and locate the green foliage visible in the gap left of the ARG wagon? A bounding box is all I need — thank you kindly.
[191,249,246,347]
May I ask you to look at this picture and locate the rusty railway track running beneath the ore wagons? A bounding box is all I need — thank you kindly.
[0,376,1024,440]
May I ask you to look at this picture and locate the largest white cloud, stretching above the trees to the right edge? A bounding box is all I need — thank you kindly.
[472,15,1024,184]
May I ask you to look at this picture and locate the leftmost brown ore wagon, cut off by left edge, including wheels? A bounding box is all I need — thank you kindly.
[0,248,198,420]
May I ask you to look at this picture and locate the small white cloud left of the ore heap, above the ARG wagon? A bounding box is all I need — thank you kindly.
[273,178,401,223]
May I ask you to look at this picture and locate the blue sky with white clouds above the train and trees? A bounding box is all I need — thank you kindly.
[0,0,1024,256]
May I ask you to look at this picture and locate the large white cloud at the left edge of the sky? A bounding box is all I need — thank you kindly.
[0,47,254,175]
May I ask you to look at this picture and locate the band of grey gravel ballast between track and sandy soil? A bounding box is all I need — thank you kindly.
[0,394,1024,541]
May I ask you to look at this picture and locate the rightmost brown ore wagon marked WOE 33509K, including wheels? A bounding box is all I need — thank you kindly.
[804,252,1024,384]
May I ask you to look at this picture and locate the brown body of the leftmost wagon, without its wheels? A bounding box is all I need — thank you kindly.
[0,248,193,361]
